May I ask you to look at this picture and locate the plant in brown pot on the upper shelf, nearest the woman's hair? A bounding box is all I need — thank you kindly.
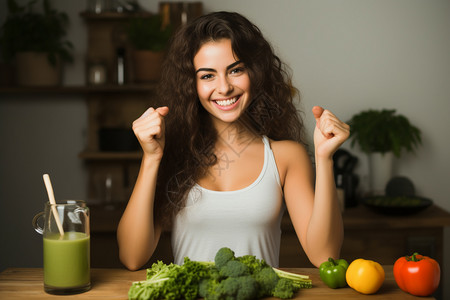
[127,15,172,82]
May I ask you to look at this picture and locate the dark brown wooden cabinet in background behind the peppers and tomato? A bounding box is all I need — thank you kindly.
[280,204,450,299]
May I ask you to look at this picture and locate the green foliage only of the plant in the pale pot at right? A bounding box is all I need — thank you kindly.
[348,109,422,157]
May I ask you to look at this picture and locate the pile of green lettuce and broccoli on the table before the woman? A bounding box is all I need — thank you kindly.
[128,248,312,300]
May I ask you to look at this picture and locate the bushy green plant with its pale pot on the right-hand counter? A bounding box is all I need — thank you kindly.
[348,109,422,194]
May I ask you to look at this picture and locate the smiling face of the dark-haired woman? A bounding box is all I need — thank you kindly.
[194,39,250,124]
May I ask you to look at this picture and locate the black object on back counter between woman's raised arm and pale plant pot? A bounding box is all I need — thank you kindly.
[333,149,359,207]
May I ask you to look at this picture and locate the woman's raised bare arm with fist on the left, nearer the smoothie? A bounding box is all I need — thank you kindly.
[117,107,169,270]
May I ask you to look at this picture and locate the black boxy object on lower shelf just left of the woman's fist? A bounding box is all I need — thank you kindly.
[98,128,139,151]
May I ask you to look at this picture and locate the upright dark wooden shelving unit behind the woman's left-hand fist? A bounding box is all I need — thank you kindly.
[79,12,162,205]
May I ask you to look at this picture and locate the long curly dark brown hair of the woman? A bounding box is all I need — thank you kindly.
[155,12,305,229]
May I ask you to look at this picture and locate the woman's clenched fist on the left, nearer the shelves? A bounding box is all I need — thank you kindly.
[133,106,169,160]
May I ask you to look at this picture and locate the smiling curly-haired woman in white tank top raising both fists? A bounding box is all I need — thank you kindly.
[117,12,349,270]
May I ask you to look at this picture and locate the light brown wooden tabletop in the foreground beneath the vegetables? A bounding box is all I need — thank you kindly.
[0,265,434,300]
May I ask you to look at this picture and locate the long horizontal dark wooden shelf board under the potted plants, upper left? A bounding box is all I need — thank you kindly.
[0,83,157,94]
